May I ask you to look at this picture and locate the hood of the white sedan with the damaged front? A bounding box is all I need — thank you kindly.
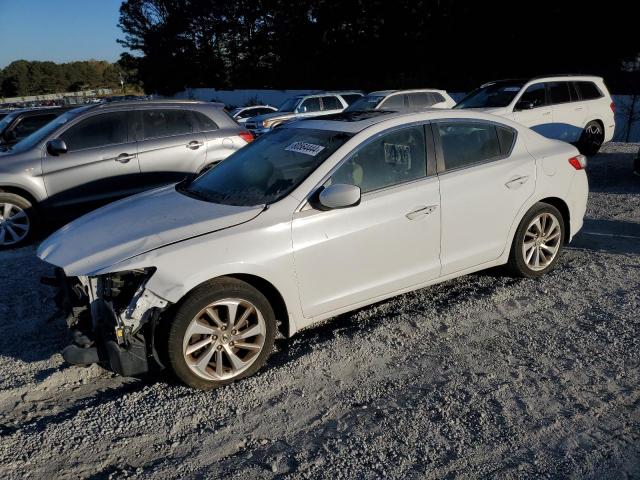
[38,185,263,276]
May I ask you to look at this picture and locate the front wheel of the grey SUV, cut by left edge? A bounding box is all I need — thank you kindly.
[0,192,36,248]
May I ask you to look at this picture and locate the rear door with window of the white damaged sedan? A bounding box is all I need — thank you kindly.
[434,119,536,275]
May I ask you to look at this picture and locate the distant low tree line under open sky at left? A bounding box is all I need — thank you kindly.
[0,60,129,98]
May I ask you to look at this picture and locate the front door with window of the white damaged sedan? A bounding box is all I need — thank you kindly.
[292,125,440,318]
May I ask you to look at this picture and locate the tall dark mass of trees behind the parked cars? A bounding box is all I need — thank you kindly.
[119,0,640,94]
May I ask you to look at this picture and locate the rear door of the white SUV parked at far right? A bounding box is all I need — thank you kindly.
[547,81,587,142]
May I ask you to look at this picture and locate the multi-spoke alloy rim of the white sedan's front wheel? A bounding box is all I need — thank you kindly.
[182,298,267,381]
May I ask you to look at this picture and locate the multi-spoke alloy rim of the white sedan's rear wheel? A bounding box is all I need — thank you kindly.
[522,212,562,272]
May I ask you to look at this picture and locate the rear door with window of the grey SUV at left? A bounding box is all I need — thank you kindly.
[137,108,206,188]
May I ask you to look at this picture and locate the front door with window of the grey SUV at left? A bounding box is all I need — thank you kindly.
[42,112,140,207]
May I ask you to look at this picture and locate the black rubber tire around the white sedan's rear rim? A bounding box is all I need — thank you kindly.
[506,202,566,278]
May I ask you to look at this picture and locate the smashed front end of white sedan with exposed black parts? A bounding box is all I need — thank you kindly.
[44,268,169,376]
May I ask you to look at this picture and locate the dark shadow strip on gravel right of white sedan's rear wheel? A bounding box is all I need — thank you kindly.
[570,219,640,255]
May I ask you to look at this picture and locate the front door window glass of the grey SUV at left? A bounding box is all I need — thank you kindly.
[60,112,127,152]
